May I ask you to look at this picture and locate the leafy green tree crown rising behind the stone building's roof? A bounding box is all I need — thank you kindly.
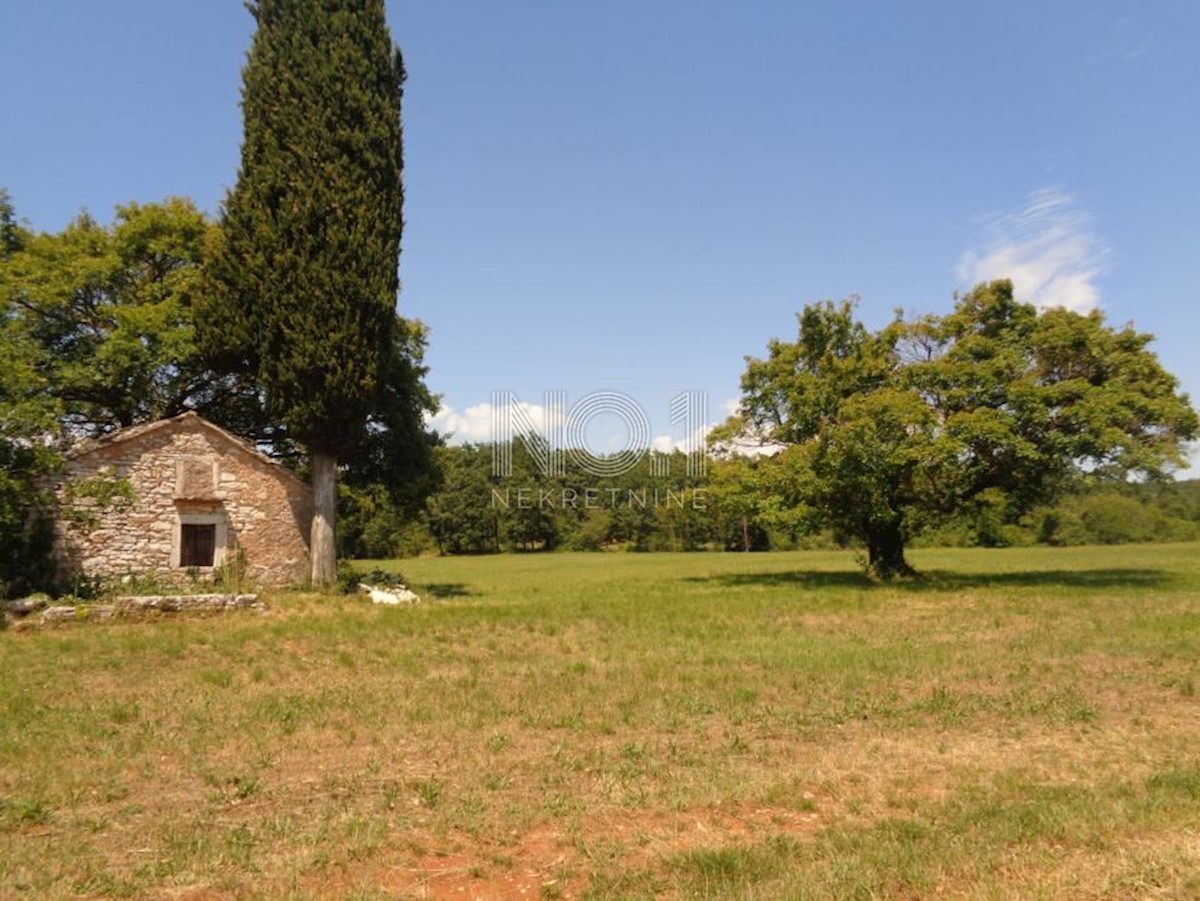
[0,198,215,437]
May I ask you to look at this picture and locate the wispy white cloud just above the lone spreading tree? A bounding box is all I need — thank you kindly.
[958,187,1108,312]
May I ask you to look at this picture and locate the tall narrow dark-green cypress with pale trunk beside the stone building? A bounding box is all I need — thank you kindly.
[198,0,404,584]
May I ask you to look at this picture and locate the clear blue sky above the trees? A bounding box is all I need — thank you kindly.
[0,0,1200,465]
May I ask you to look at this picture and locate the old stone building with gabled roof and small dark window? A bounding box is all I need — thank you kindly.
[55,413,312,585]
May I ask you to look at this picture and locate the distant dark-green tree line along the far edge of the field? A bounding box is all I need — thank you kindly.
[338,439,1200,559]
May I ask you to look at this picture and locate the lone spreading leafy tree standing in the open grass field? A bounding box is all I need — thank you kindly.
[718,281,1198,578]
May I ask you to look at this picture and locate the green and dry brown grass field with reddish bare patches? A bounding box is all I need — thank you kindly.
[0,545,1200,900]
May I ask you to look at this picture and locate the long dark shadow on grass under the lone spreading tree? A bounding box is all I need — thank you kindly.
[683,569,1183,593]
